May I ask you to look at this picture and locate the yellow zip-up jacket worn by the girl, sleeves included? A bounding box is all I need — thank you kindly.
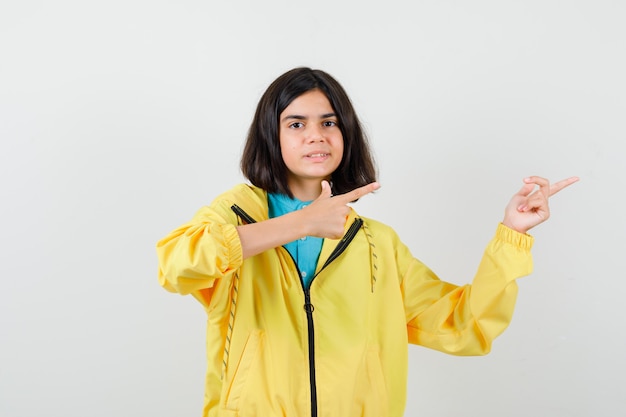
[157,184,533,417]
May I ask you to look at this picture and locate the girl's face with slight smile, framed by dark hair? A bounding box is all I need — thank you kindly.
[279,90,343,199]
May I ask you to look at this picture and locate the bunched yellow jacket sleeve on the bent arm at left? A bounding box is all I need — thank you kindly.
[156,198,243,305]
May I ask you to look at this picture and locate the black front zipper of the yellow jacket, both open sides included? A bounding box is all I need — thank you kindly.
[231,204,363,417]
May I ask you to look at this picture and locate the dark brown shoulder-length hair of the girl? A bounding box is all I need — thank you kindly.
[241,67,376,197]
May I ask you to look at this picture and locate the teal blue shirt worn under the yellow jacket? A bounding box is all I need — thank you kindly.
[267,193,324,288]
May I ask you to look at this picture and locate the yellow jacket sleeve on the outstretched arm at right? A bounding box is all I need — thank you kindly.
[398,224,533,355]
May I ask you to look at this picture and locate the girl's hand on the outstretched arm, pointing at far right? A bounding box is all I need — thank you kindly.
[502,177,578,233]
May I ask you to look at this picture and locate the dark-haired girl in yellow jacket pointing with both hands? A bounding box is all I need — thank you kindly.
[157,68,577,417]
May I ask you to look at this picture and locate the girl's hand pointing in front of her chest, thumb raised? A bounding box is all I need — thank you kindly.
[301,181,380,239]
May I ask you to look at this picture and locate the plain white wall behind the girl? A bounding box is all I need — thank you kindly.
[0,0,626,417]
